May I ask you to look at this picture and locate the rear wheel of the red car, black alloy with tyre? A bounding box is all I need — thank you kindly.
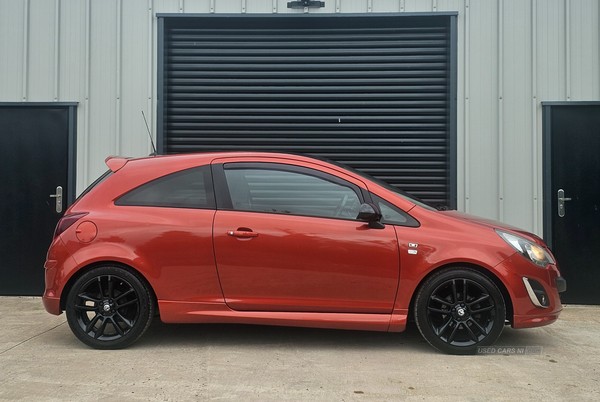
[66,266,154,349]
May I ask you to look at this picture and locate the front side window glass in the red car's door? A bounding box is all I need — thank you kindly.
[225,168,360,219]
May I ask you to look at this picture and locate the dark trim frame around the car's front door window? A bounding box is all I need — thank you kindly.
[216,162,368,222]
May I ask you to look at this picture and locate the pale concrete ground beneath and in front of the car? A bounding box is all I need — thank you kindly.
[0,297,600,402]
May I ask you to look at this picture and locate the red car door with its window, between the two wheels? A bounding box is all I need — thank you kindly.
[213,163,400,313]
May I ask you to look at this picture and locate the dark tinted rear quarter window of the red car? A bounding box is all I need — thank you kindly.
[115,166,215,208]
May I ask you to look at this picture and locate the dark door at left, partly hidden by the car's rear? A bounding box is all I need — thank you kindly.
[0,103,76,295]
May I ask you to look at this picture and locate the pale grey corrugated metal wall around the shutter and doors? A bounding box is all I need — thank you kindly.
[0,0,600,234]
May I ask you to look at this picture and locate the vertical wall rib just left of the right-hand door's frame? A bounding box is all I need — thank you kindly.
[531,0,541,233]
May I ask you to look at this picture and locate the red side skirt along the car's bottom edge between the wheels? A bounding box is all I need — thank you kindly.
[158,300,408,332]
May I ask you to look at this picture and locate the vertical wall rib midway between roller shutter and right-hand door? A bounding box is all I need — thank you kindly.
[498,0,504,222]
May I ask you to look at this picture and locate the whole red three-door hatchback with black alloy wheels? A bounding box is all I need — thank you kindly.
[43,152,566,354]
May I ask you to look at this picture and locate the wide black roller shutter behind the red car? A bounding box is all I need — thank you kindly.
[159,15,456,205]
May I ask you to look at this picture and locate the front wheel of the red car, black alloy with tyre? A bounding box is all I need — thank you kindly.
[414,268,506,354]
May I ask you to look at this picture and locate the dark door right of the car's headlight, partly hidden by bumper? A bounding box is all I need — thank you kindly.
[544,102,600,304]
